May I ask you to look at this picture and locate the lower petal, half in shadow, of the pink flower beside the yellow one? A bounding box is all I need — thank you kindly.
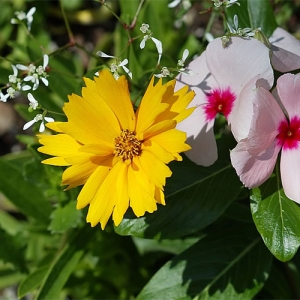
[176,106,218,166]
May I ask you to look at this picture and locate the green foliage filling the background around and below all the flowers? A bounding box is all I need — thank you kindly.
[0,0,300,299]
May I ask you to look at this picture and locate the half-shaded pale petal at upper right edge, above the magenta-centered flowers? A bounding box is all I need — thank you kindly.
[269,27,300,72]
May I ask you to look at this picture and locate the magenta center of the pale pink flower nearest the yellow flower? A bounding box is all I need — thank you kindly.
[204,87,236,121]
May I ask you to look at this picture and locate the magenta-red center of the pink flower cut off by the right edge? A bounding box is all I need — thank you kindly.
[276,116,300,150]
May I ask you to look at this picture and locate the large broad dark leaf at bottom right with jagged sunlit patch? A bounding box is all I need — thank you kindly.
[137,223,272,300]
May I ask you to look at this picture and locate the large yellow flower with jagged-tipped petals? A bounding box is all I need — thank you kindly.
[38,70,194,229]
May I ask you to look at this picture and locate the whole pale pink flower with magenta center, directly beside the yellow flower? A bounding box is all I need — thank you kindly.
[177,37,274,166]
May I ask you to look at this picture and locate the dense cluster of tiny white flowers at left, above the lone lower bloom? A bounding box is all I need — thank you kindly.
[17,54,49,90]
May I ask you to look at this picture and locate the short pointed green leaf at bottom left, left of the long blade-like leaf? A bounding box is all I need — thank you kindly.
[18,265,49,298]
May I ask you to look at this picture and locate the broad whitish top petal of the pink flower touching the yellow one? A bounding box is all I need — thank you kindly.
[206,37,274,94]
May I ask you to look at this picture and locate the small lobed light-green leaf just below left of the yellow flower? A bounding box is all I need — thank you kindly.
[48,201,82,233]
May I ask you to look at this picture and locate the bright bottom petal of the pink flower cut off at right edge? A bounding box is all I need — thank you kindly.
[280,149,300,203]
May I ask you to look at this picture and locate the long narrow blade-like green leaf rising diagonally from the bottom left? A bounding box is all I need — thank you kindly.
[36,225,95,300]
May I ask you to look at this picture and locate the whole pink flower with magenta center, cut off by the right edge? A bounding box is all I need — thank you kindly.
[231,74,300,203]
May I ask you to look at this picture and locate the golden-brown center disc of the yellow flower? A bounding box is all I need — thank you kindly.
[114,129,142,162]
